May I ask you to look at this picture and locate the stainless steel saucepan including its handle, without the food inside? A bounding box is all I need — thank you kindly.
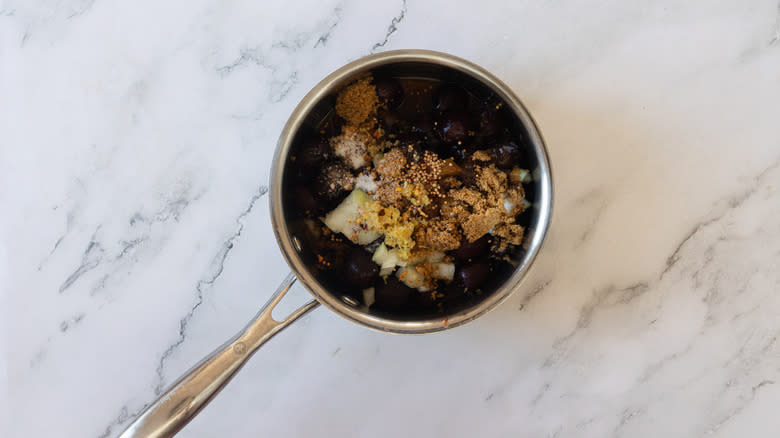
[120,50,553,438]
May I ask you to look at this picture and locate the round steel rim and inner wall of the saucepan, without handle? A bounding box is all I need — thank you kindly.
[269,50,553,334]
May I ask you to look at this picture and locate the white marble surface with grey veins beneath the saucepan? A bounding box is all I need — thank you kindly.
[0,0,780,438]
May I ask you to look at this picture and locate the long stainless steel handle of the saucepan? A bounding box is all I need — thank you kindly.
[119,274,319,438]
